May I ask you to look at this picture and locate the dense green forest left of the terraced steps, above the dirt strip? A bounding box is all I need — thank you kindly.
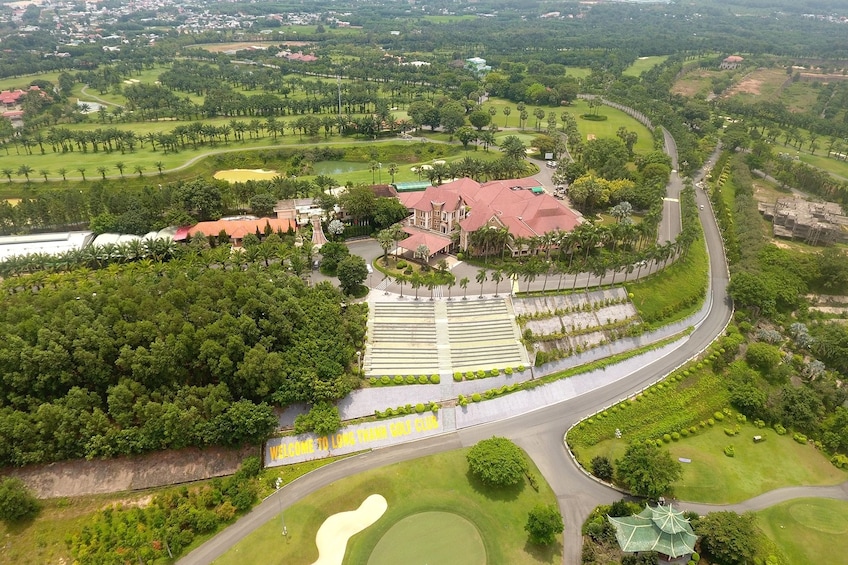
[0,260,365,465]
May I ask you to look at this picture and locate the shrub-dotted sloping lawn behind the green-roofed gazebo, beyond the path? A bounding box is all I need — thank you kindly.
[581,424,848,502]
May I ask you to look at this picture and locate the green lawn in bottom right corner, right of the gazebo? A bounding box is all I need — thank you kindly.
[756,498,848,565]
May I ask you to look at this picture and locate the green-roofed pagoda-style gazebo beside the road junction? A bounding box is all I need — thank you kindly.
[607,505,698,561]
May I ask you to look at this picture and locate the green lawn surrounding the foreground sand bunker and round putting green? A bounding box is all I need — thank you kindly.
[215,449,562,565]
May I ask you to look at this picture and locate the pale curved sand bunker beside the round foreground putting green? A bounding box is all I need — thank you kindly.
[312,494,389,565]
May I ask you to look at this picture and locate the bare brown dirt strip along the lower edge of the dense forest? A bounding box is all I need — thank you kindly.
[0,447,258,498]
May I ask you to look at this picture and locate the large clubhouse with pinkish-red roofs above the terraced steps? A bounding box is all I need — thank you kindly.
[398,178,583,256]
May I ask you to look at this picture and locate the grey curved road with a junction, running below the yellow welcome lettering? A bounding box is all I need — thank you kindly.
[179,162,744,565]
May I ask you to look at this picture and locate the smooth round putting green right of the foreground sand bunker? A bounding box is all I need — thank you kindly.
[368,512,486,565]
